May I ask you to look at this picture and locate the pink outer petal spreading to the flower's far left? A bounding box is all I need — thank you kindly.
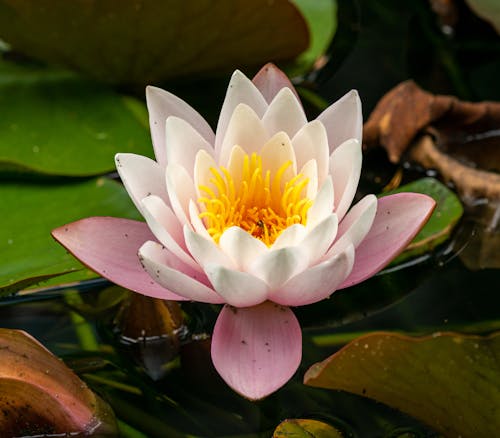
[52,217,184,300]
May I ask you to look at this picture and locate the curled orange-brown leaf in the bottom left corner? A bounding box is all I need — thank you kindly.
[0,329,117,437]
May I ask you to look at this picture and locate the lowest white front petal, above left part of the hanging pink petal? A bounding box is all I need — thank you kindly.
[205,264,269,307]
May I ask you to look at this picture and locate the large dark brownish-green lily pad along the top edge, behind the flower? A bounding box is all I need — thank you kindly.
[0,0,309,85]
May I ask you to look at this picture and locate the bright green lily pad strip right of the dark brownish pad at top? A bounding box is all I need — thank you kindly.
[286,0,337,76]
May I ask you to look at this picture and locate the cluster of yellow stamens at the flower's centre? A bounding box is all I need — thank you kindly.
[198,153,312,246]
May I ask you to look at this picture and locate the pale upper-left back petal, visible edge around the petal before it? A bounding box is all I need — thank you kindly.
[146,86,215,168]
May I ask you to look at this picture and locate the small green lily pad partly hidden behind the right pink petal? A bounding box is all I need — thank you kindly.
[384,178,464,265]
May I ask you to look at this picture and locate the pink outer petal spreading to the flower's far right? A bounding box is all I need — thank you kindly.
[339,193,436,289]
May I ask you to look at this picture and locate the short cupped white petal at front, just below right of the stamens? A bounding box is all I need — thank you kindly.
[250,247,307,290]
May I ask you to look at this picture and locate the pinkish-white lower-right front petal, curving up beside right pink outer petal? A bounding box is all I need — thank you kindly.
[269,245,354,306]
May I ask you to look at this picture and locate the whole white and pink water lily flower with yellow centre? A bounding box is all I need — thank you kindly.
[53,64,434,400]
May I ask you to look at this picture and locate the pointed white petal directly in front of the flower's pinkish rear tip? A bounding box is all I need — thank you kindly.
[262,88,307,138]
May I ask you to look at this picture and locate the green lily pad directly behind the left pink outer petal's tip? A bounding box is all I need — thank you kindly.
[0,178,139,295]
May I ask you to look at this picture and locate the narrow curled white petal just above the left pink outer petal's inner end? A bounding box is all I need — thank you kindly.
[142,196,201,270]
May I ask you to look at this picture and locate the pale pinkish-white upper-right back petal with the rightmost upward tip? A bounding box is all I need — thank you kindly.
[318,90,363,153]
